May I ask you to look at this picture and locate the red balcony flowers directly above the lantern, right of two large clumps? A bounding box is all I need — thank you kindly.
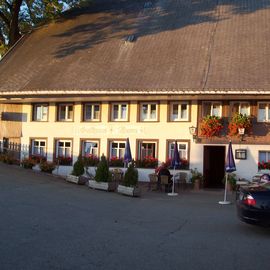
[228,113,252,136]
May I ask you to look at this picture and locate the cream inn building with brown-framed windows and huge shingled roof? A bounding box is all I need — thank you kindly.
[0,0,270,187]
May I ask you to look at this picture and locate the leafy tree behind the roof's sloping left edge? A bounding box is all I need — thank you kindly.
[0,0,82,47]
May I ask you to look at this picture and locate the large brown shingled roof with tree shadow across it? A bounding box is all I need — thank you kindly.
[0,0,270,96]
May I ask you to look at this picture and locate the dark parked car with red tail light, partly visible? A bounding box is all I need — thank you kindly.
[236,182,270,226]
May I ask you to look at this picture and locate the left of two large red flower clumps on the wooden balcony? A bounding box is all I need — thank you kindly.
[200,115,223,138]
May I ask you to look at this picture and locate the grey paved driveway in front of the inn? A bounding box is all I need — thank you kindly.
[0,164,270,270]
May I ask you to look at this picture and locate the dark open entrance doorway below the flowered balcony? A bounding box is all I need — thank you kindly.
[203,146,225,188]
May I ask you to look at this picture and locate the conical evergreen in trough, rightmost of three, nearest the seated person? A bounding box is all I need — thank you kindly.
[117,162,141,197]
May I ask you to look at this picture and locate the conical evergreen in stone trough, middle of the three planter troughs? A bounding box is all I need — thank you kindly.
[88,155,116,191]
